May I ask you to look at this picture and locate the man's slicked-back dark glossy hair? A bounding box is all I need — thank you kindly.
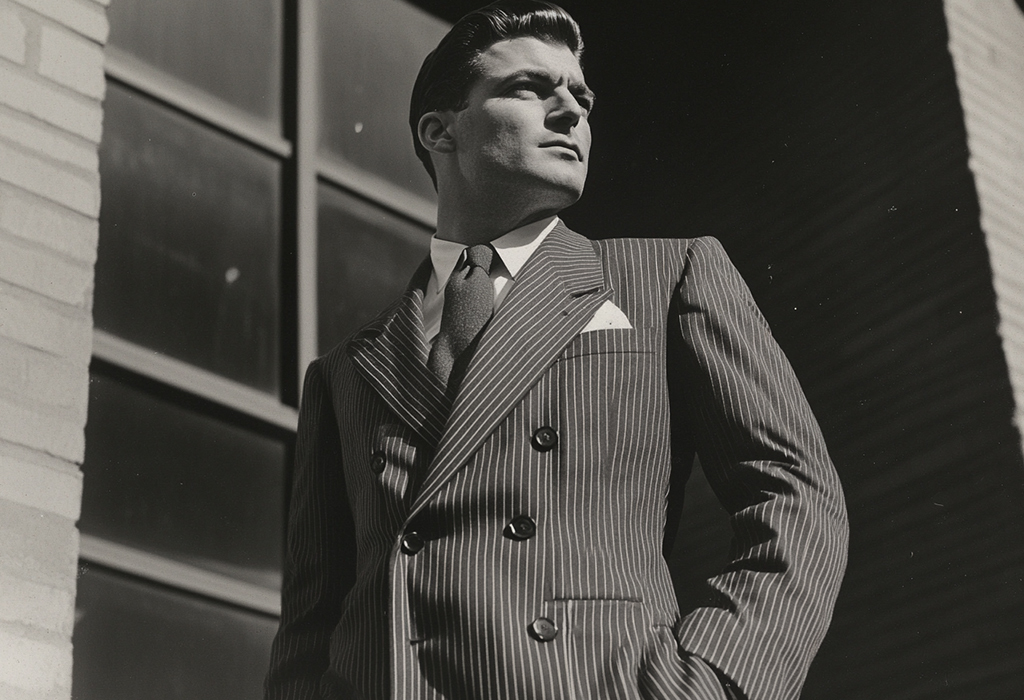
[409,0,583,187]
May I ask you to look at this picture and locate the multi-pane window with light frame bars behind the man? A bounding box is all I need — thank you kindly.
[74,0,447,700]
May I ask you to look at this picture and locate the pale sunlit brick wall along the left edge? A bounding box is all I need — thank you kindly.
[0,0,109,700]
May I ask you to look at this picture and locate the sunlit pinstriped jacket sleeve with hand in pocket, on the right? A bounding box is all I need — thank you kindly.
[669,238,849,700]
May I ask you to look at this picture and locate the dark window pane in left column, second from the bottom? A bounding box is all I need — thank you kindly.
[80,373,287,588]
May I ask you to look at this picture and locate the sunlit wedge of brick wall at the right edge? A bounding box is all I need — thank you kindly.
[945,0,1024,454]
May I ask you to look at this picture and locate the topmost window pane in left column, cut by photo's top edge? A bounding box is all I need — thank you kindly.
[106,0,283,125]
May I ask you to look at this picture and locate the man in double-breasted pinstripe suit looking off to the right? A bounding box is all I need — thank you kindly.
[267,0,847,700]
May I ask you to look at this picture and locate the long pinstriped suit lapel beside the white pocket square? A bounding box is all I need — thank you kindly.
[410,223,612,517]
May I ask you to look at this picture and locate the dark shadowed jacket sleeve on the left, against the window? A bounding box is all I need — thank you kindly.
[263,360,355,700]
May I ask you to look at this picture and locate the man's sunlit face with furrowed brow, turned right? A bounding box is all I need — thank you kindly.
[450,37,594,211]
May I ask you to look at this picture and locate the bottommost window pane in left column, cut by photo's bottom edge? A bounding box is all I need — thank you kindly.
[72,565,278,700]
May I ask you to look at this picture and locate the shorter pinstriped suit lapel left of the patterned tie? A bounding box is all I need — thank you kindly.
[348,258,452,447]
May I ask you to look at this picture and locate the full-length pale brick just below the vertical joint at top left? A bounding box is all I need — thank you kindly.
[0,63,103,143]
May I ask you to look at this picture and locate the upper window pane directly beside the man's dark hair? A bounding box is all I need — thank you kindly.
[319,0,447,202]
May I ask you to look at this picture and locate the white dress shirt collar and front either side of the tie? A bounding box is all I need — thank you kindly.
[423,216,558,345]
